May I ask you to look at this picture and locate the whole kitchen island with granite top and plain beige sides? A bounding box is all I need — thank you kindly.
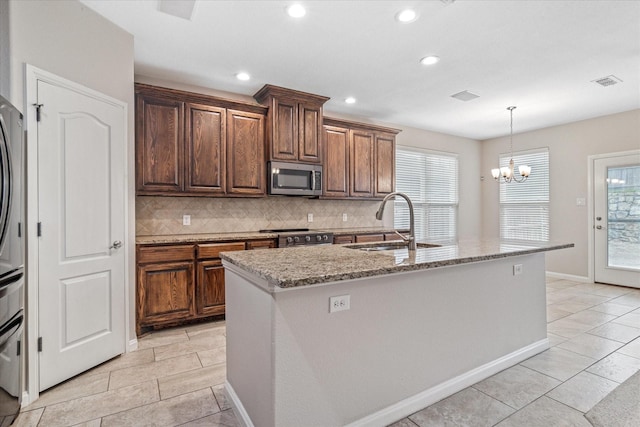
[222,240,573,427]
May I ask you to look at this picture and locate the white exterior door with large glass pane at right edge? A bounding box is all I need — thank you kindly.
[593,154,640,288]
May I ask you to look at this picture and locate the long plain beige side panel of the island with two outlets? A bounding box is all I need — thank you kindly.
[270,254,548,426]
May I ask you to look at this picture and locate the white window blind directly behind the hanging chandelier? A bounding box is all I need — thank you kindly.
[500,148,549,241]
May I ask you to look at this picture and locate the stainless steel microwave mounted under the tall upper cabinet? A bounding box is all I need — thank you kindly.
[268,162,322,197]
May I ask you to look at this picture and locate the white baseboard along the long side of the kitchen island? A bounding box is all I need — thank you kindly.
[346,338,549,427]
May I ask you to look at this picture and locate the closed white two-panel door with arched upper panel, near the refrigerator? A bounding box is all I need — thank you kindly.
[37,80,125,391]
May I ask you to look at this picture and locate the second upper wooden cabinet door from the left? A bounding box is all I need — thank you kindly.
[185,104,227,194]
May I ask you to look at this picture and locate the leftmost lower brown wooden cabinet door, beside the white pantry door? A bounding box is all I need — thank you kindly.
[137,261,195,327]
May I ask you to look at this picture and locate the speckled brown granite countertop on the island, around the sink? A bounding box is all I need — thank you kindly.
[221,239,573,291]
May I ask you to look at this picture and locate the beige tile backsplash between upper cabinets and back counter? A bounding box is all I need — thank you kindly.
[136,196,389,236]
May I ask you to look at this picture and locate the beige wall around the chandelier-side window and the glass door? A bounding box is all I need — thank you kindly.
[481,110,640,277]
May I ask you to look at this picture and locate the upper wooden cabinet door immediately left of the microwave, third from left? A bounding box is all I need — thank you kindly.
[227,110,266,196]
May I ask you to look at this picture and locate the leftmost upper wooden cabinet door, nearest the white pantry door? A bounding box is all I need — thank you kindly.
[136,95,184,194]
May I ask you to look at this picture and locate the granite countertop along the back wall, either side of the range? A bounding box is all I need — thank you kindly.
[136,228,406,245]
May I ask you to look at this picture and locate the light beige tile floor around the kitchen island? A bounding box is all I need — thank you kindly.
[12,279,640,427]
